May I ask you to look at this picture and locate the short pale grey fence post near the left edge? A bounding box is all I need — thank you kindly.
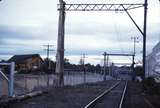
[9,62,15,97]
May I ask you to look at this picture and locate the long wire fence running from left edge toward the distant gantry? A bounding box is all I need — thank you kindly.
[0,61,135,97]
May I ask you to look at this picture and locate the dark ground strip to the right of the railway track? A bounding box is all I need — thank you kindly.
[123,81,160,108]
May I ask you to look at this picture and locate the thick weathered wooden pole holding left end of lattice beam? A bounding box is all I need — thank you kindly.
[56,0,66,86]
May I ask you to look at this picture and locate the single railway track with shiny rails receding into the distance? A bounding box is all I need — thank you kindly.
[84,80,127,108]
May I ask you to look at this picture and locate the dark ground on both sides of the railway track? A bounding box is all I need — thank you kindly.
[0,80,160,108]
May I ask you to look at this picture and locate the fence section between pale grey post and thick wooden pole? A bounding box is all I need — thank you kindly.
[14,74,55,95]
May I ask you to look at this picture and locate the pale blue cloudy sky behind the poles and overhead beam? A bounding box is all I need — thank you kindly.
[0,0,160,64]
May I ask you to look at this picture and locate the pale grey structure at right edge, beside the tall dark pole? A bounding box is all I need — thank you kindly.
[146,42,160,76]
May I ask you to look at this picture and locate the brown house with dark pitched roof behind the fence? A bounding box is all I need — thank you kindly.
[8,54,43,71]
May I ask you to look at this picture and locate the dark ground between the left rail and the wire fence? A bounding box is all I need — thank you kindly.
[7,81,117,108]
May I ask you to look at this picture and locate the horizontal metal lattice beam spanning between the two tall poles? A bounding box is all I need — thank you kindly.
[58,4,144,11]
